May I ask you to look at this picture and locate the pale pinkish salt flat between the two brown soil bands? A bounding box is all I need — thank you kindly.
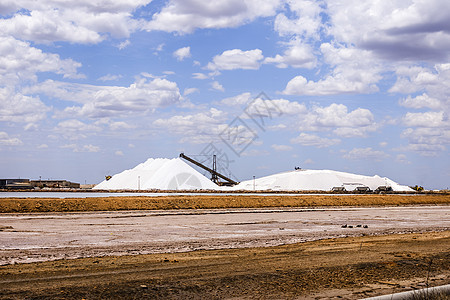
[0,205,450,264]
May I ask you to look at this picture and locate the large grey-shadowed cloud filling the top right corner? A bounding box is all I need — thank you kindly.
[327,0,450,61]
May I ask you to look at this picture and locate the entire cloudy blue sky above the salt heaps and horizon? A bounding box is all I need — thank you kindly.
[0,0,450,189]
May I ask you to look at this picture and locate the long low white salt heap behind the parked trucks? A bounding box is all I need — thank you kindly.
[233,170,412,192]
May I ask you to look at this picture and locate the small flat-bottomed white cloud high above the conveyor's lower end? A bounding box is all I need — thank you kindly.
[207,49,264,70]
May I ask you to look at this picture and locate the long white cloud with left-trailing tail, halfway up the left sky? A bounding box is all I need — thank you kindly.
[27,78,181,118]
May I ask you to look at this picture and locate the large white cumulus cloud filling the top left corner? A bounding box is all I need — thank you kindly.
[0,0,149,44]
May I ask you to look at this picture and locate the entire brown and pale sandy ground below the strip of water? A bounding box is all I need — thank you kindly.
[0,195,450,299]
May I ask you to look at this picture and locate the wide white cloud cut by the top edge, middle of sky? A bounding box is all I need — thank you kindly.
[143,0,281,33]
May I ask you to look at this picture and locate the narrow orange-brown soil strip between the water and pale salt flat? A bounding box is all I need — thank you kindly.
[0,194,450,213]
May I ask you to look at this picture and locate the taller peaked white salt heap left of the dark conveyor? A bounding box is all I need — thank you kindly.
[94,158,219,190]
